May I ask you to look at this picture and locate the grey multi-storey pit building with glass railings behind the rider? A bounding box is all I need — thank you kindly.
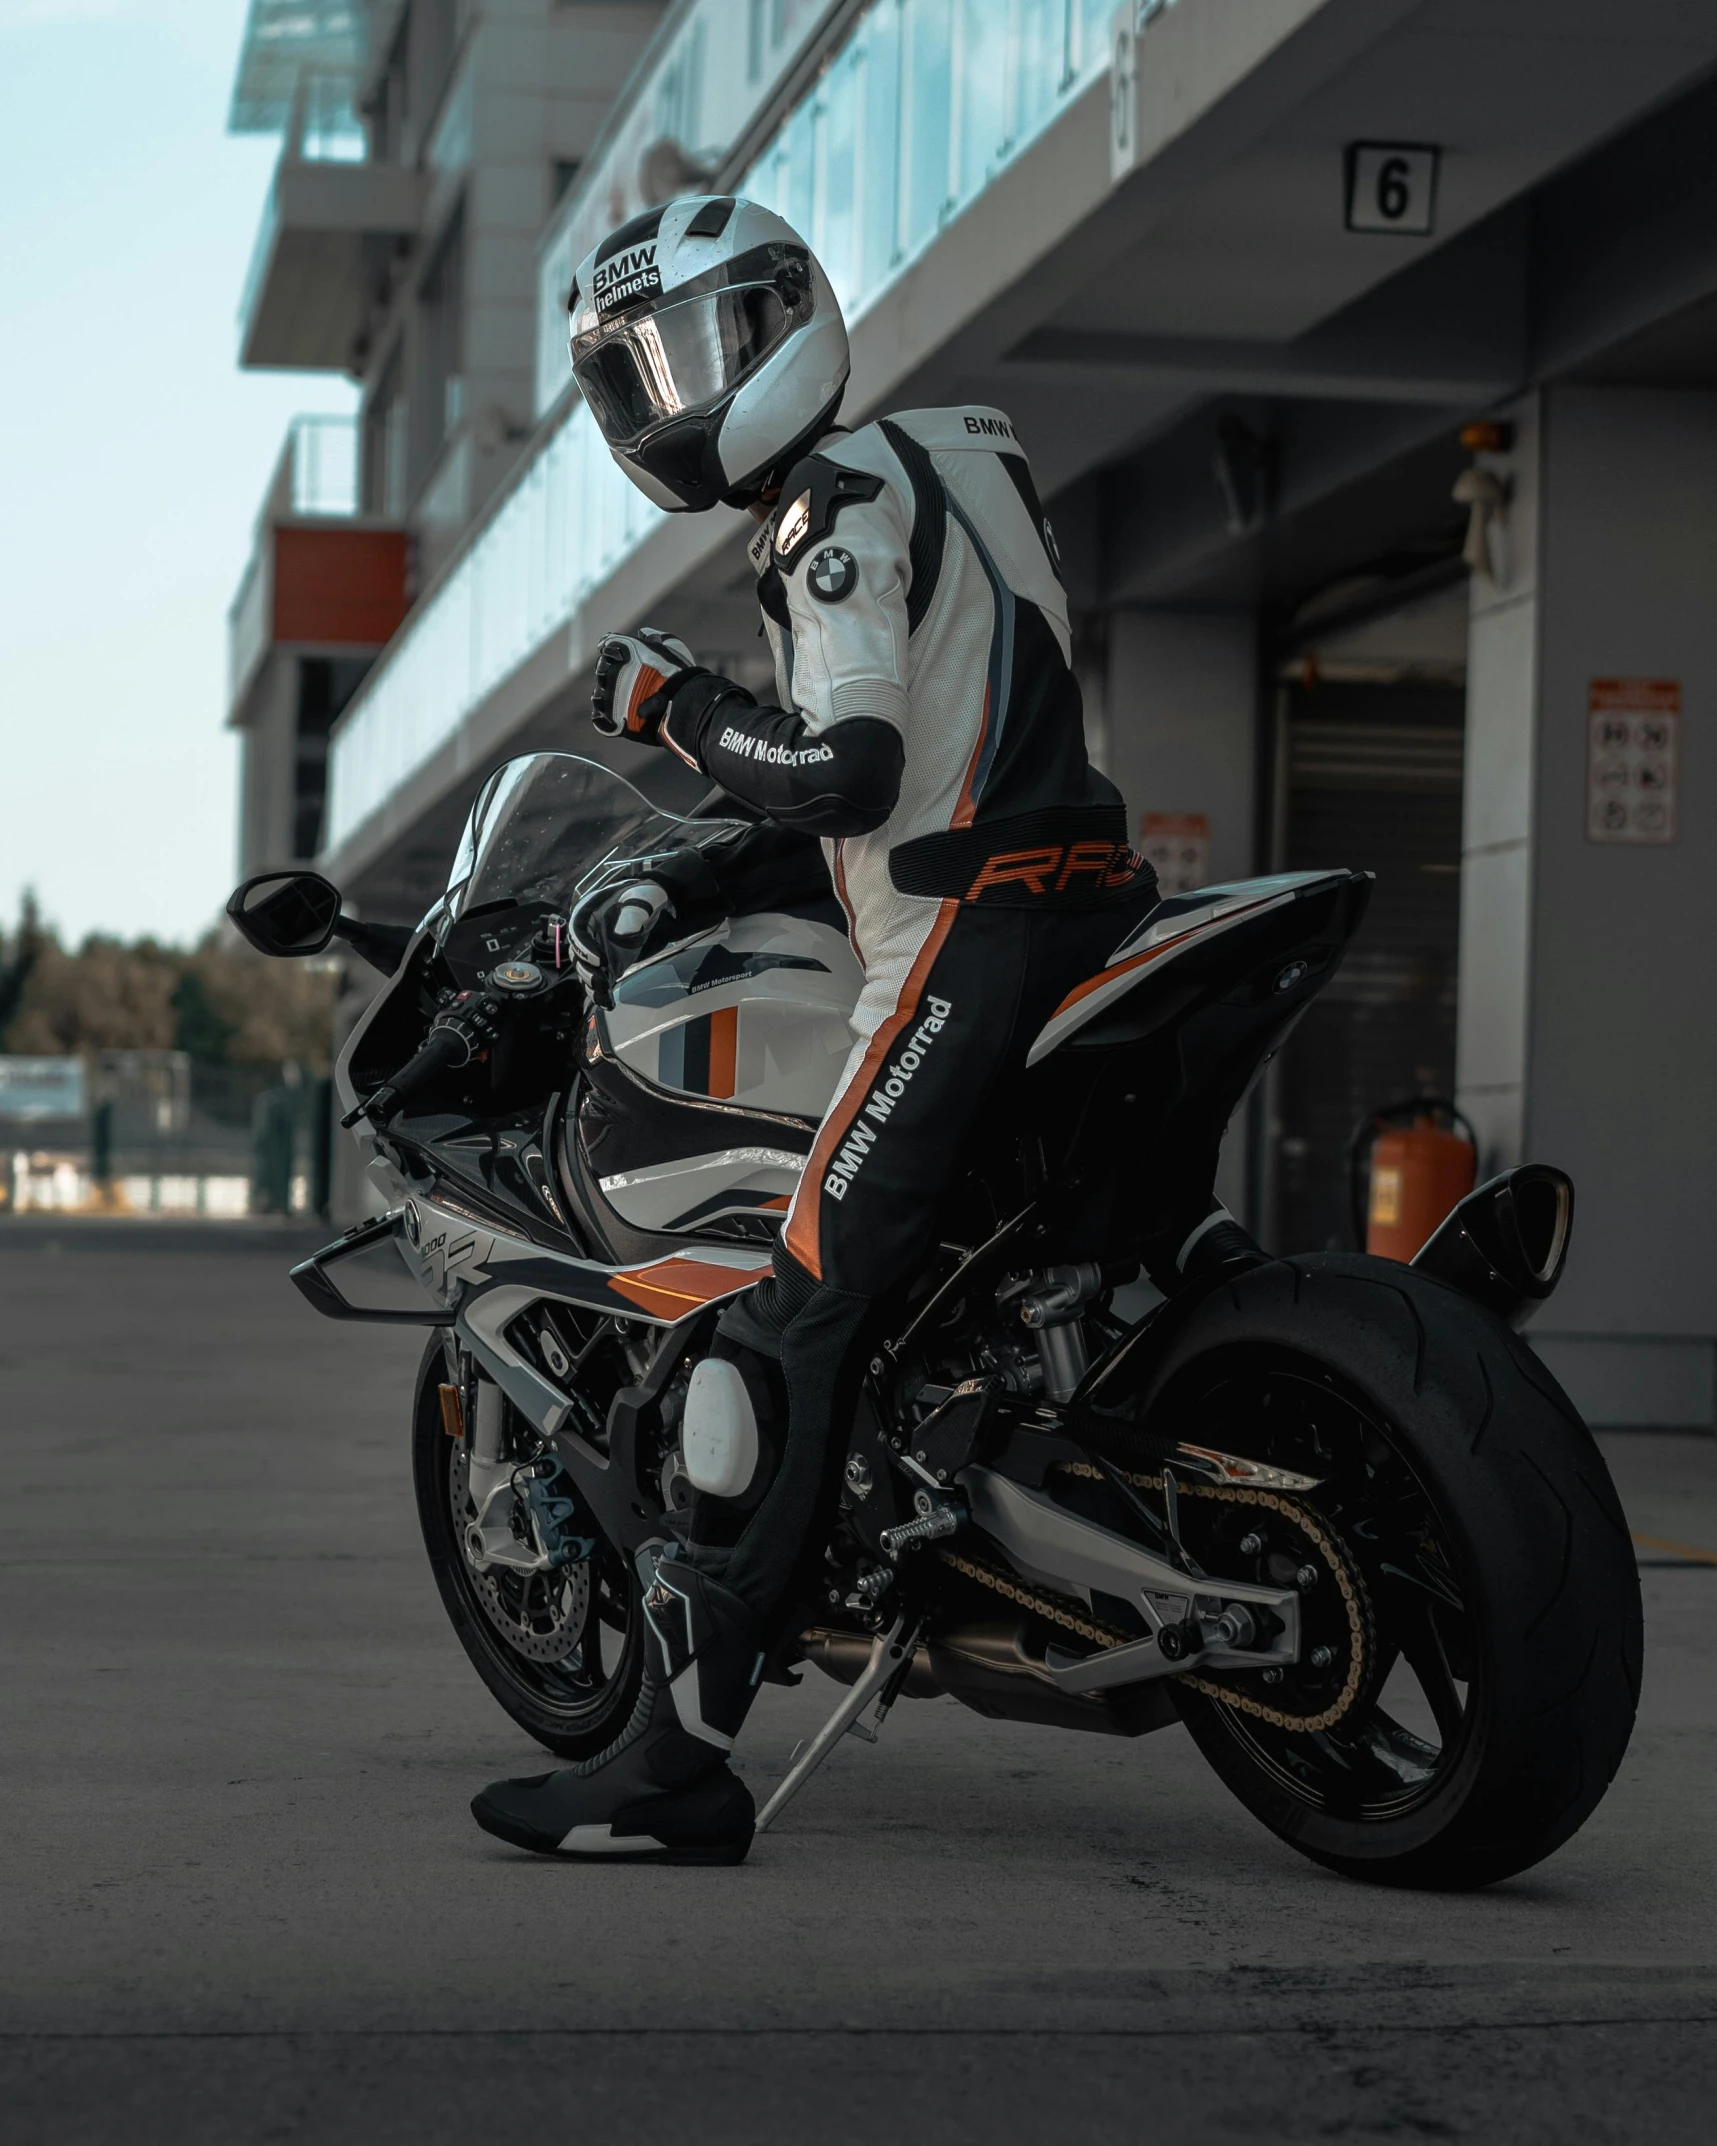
[232,12,1717,1425]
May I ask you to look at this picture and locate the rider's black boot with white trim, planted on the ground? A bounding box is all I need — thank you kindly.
[472,1552,762,1863]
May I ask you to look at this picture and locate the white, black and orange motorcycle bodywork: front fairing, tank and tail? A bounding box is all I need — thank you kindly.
[294,753,1367,1579]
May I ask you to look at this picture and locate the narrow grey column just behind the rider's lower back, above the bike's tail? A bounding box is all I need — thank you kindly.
[1103,612,1258,1225]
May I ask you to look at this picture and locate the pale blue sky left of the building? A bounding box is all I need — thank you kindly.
[0,0,354,942]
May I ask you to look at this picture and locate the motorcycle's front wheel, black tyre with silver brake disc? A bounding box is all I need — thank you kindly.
[412,1339,644,1760]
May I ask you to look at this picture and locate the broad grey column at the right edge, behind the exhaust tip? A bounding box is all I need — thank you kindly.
[1457,386,1717,1427]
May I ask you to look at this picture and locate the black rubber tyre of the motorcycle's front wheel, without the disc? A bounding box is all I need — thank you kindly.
[412,1337,644,1760]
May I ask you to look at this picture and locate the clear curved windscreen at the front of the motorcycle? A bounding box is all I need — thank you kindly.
[436,753,743,944]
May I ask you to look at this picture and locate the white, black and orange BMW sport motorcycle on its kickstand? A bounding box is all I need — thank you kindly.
[230,753,1642,1886]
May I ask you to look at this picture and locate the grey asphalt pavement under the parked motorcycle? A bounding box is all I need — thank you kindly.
[0,1221,1717,2146]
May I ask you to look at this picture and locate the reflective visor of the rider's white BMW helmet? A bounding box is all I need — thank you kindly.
[573,283,807,446]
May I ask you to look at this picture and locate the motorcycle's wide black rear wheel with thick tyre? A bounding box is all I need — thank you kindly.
[1138,1255,1642,1888]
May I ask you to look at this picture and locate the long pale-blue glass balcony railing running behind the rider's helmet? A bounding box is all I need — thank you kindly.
[328,0,1150,848]
